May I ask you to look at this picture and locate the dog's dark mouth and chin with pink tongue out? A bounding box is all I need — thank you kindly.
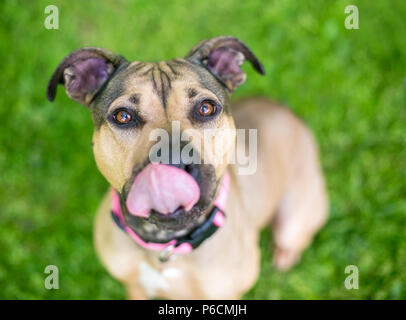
[119,163,216,233]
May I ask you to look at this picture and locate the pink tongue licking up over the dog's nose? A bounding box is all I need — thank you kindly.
[127,163,200,217]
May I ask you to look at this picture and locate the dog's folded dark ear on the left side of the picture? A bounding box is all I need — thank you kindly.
[47,47,126,106]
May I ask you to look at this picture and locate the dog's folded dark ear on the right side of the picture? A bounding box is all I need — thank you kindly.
[185,36,265,93]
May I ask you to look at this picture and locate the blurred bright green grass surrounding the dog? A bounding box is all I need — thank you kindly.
[0,0,406,299]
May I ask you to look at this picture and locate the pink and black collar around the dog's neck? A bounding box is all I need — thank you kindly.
[111,172,230,261]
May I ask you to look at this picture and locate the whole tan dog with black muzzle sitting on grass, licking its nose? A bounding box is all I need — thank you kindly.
[47,36,328,299]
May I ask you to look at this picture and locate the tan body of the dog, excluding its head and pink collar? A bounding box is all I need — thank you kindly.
[94,99,326,299]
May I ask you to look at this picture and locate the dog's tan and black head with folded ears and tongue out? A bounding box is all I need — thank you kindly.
[47,37,264,240]
